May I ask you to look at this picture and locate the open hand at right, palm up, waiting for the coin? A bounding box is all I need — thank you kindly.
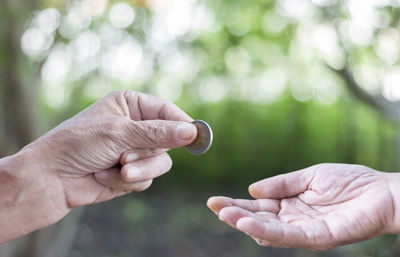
[207,164,399,251]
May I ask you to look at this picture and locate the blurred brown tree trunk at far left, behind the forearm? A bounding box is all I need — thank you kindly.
[0,0,82,257]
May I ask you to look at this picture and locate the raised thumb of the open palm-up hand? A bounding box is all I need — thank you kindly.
[249,169,312,199]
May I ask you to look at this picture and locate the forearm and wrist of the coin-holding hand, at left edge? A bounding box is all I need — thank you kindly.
[0,149,68,244]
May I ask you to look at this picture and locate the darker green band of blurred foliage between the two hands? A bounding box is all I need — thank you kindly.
[166,97,397,189]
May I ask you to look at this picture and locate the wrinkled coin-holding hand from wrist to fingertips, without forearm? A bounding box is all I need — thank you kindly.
[20,91,197,208]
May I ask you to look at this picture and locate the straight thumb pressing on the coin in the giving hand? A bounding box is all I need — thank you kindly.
[128,120,197,149]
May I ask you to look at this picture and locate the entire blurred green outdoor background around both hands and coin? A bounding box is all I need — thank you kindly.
[0,0,400,257]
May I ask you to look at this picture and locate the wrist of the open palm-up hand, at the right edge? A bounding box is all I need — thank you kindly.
[385,173,400,234]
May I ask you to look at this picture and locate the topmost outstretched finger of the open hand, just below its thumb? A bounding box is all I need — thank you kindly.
[207,196,280,214]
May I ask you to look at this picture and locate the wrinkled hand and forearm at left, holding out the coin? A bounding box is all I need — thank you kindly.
[0,91,211,244]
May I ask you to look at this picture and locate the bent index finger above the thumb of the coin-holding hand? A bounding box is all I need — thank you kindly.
[125,91,193,122]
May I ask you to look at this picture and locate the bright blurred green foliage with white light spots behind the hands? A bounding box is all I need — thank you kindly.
[21,0,400,187]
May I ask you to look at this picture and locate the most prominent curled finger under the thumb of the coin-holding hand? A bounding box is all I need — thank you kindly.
[121,153,172,182]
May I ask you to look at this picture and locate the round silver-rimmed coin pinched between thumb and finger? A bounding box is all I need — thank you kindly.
[186,120,213,155]
